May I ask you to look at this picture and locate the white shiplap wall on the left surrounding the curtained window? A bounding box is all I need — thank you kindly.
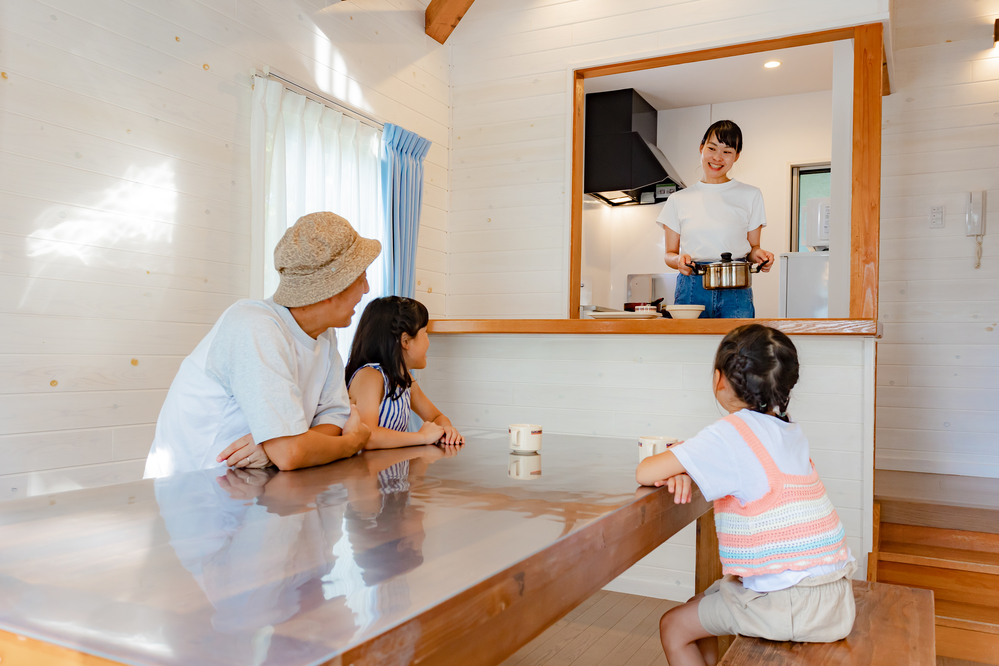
[0,0,450,500]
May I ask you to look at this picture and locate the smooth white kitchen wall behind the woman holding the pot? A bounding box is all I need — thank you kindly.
[583,91,832,317]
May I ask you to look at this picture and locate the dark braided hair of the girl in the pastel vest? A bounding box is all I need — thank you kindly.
[715,324,798,422]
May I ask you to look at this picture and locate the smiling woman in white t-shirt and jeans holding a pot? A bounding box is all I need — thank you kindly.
[656,120,774,319]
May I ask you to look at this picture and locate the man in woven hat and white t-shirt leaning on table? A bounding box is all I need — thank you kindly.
[144,213,381,478]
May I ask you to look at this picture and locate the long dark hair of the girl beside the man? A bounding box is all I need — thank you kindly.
[344,296,430,400]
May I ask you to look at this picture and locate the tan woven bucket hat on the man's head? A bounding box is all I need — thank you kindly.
[274,213,382,308]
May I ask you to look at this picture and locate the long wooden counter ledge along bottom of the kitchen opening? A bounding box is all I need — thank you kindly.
[427,318,881,337]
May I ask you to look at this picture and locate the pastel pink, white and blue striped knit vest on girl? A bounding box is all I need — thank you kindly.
[715,414,849,576]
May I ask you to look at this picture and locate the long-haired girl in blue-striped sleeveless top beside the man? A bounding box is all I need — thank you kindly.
[345,296,465,449]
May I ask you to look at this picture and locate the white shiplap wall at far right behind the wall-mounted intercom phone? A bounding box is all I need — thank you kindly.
[877,0,999,478]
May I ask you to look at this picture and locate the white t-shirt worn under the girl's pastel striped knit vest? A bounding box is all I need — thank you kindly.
[670,409,853,592]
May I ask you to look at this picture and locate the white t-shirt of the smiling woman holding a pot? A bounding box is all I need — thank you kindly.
[656,180,767,261]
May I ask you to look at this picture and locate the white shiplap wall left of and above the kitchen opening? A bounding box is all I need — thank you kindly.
[447,0,888,317]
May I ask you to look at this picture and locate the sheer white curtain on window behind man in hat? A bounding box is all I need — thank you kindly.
[250,76,388,363]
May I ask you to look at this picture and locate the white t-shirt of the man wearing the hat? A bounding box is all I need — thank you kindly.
[143,299,350,478]
